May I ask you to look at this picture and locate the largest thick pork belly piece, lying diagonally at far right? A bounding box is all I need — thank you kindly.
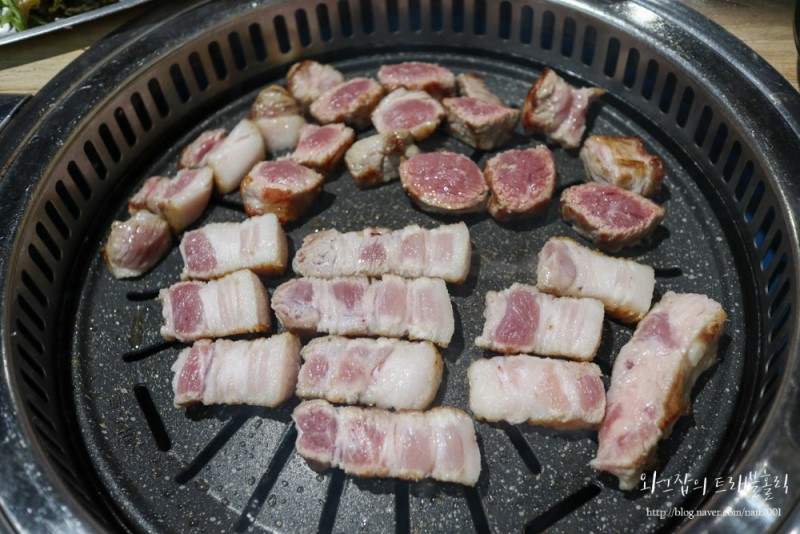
[590,291,727,490]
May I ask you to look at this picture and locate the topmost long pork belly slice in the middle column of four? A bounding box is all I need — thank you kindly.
[292,222,472,283]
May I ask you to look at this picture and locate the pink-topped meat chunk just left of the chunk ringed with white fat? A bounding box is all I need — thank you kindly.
[309,78,383,130]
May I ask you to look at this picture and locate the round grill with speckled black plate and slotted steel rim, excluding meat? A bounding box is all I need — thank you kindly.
[0,0,800,532]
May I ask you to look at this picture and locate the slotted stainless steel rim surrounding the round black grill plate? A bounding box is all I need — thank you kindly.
[0,0,800,529]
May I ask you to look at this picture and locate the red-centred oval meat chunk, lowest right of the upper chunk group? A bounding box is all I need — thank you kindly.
[561,183,664,252]
